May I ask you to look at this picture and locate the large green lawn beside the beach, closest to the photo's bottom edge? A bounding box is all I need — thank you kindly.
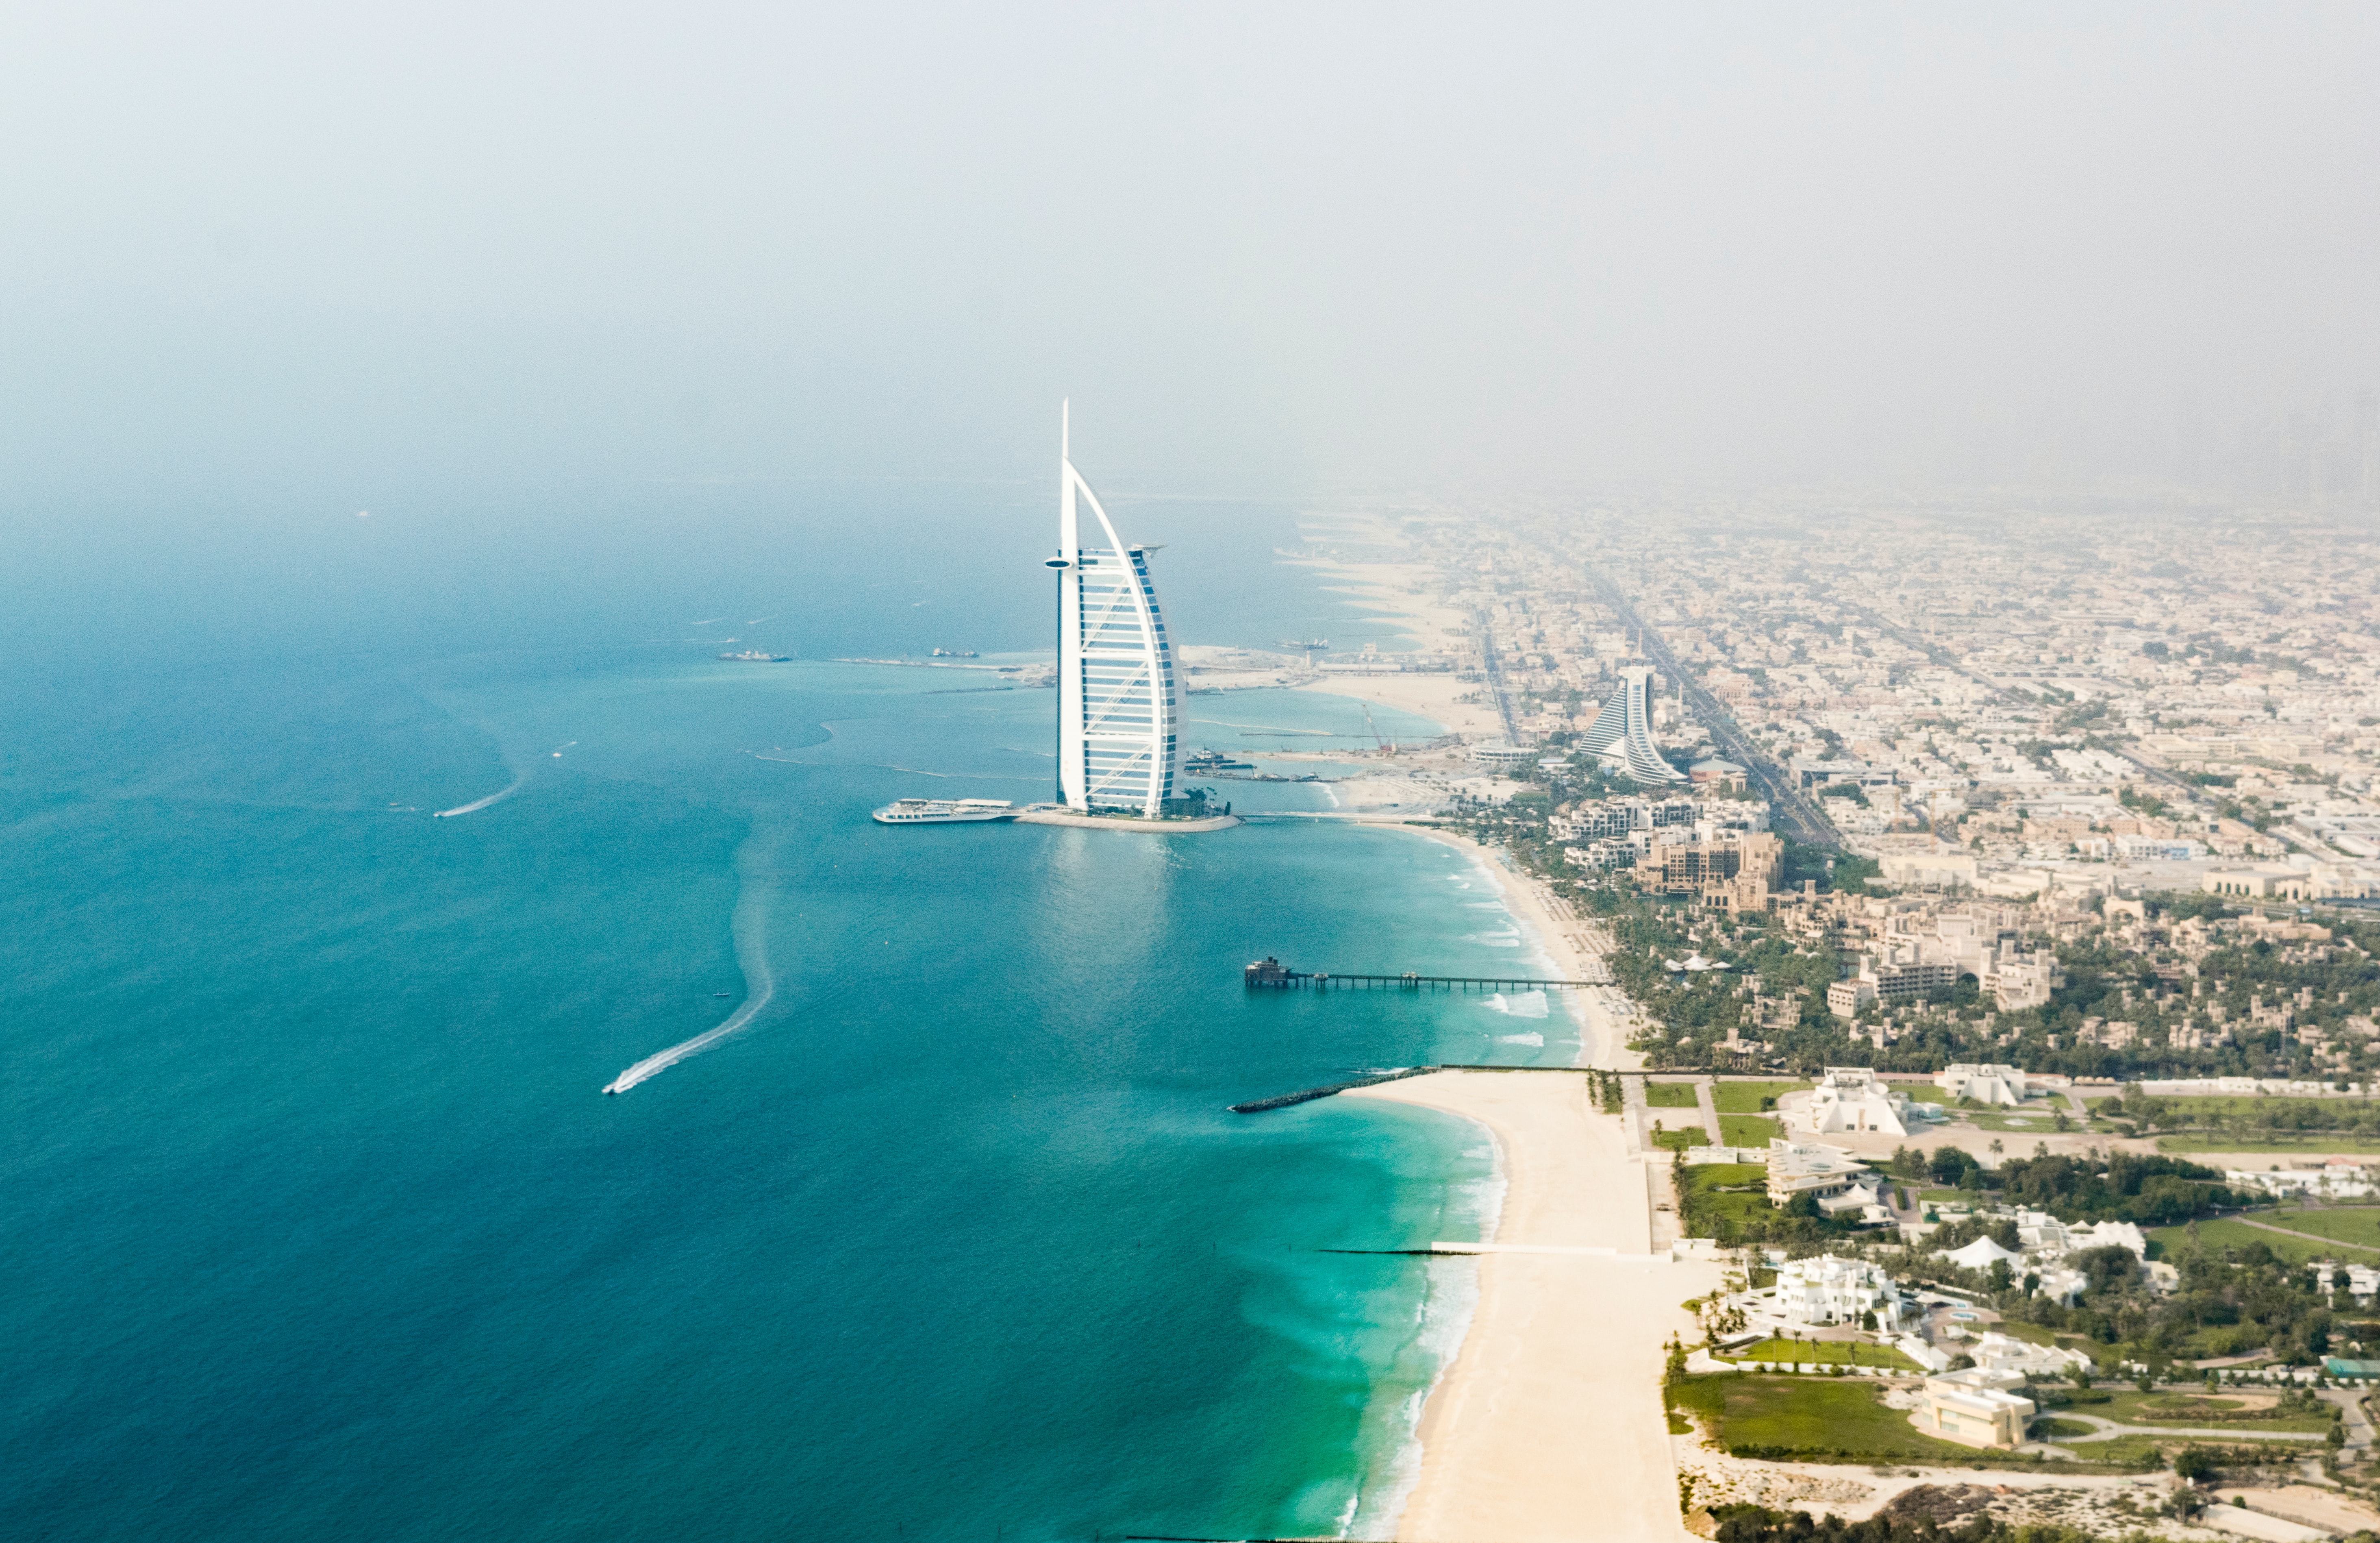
[1671,1371,2154,1471]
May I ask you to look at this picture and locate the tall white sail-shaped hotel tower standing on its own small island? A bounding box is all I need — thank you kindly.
[1050,407,1185,819]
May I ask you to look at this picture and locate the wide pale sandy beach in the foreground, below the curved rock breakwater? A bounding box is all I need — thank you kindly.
[1342,1071,1718,1543]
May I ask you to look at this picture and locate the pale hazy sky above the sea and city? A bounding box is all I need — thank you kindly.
[0,0,2380,500]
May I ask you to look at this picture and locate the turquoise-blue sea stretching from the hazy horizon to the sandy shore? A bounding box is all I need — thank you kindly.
[0,481,1578,1543]
